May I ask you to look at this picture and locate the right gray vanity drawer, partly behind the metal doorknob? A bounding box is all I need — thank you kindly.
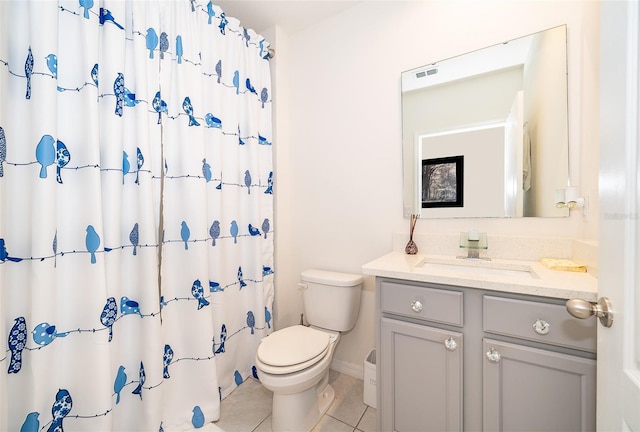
[483,295,597,352]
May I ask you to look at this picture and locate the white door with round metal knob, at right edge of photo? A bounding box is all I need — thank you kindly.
[597,0,640,432]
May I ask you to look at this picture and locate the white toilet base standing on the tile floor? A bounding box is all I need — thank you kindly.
[271,380,336,432]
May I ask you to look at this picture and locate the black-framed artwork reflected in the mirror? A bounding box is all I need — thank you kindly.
[422,156,464,208]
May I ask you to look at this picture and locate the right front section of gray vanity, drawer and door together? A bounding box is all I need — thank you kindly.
[482,294,596,432]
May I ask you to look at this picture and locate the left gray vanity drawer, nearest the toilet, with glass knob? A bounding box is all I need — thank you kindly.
[380,282,463,327]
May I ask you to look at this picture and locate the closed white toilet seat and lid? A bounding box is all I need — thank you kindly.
[256,325,332,375]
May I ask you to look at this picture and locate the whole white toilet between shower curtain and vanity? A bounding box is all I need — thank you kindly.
[256,270,362,432]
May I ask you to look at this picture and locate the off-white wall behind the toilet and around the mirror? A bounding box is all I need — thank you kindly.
[265,0,599,370]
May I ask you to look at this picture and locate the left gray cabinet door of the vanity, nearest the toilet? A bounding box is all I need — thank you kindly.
[378,318,462,432]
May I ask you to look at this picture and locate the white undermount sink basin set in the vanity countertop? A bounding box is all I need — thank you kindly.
[415,258,538,279]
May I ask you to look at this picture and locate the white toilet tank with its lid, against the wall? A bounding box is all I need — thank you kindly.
[300,270,363,331]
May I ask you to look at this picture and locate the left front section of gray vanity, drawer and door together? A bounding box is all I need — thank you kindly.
[378,282,464,432]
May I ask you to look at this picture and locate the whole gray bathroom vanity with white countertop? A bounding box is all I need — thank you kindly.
[363,252,597,432]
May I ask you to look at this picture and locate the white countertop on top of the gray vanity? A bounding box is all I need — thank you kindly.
[362,252,598,302]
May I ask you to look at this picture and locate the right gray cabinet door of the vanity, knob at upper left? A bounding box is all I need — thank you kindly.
[482,339,596,432]
